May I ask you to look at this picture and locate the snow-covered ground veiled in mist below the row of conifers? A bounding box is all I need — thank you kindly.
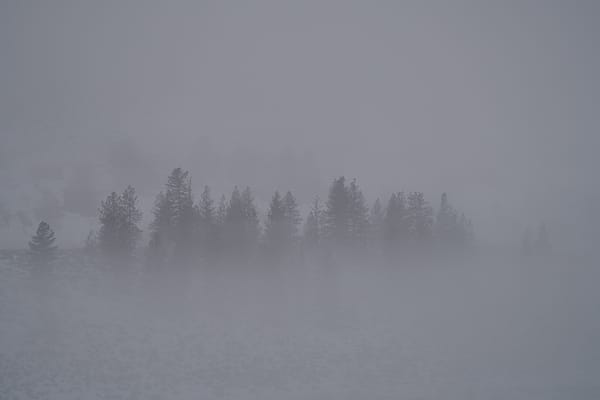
[0,258,600,400]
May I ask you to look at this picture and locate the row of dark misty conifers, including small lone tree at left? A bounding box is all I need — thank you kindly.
[30,168,474,270]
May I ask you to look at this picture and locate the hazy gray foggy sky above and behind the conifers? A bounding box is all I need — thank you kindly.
[0,0,600,248]
